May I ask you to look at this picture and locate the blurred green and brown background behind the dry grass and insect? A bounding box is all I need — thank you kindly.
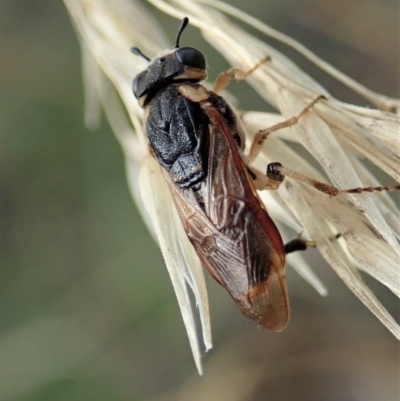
[0,0,400,401]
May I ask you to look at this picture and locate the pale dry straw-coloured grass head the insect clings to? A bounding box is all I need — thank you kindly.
[64,0,400,372]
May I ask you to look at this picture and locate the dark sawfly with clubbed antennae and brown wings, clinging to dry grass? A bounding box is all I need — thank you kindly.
[132,18,399,331]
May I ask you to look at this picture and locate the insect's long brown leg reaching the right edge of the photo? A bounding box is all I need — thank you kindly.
[267,163,400,196]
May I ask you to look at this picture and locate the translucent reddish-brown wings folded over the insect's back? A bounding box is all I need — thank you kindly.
[163,107,289,331]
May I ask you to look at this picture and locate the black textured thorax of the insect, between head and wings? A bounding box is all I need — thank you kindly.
[146,81,240,188]
